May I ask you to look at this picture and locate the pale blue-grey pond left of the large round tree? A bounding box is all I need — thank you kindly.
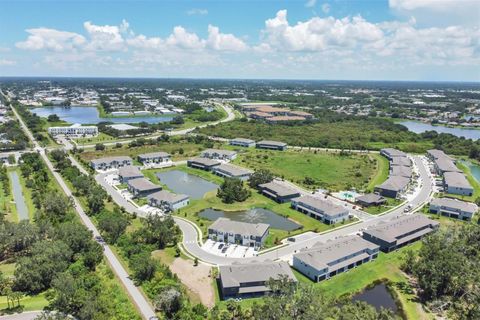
[156,170,218,199]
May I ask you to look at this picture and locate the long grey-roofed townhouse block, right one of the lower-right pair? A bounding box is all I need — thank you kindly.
[363,214,440,252]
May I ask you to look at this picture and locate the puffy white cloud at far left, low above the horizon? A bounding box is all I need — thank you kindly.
[15,28,86,51]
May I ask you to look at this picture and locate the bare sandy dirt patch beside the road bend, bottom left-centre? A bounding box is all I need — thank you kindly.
[170,258,215,308]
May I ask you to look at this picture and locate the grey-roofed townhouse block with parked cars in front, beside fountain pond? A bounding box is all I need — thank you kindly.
[208,218,270,248]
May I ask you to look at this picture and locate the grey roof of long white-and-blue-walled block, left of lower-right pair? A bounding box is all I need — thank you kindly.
[293,236,379,270]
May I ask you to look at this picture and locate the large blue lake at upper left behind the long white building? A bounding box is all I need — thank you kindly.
[31,106,172,124]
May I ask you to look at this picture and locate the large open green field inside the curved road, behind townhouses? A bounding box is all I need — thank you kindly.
[234,149,378,191]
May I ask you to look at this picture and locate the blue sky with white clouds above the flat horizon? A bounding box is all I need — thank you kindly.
[0,0,480,81]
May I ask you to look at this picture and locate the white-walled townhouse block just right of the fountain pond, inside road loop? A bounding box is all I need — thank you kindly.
[291,196,348,224]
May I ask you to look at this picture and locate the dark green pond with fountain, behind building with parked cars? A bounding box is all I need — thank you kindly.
[198,208,301,231]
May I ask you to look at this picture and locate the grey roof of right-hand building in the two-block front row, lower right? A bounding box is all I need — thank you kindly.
[364,214,439,242]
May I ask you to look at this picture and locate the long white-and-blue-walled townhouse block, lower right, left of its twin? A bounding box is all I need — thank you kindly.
[293,236,380,282]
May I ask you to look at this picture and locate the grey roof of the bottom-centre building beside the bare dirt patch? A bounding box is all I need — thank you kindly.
[219,261,297,289]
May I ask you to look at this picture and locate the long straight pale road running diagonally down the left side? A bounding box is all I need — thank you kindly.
[12,108,156,319]
